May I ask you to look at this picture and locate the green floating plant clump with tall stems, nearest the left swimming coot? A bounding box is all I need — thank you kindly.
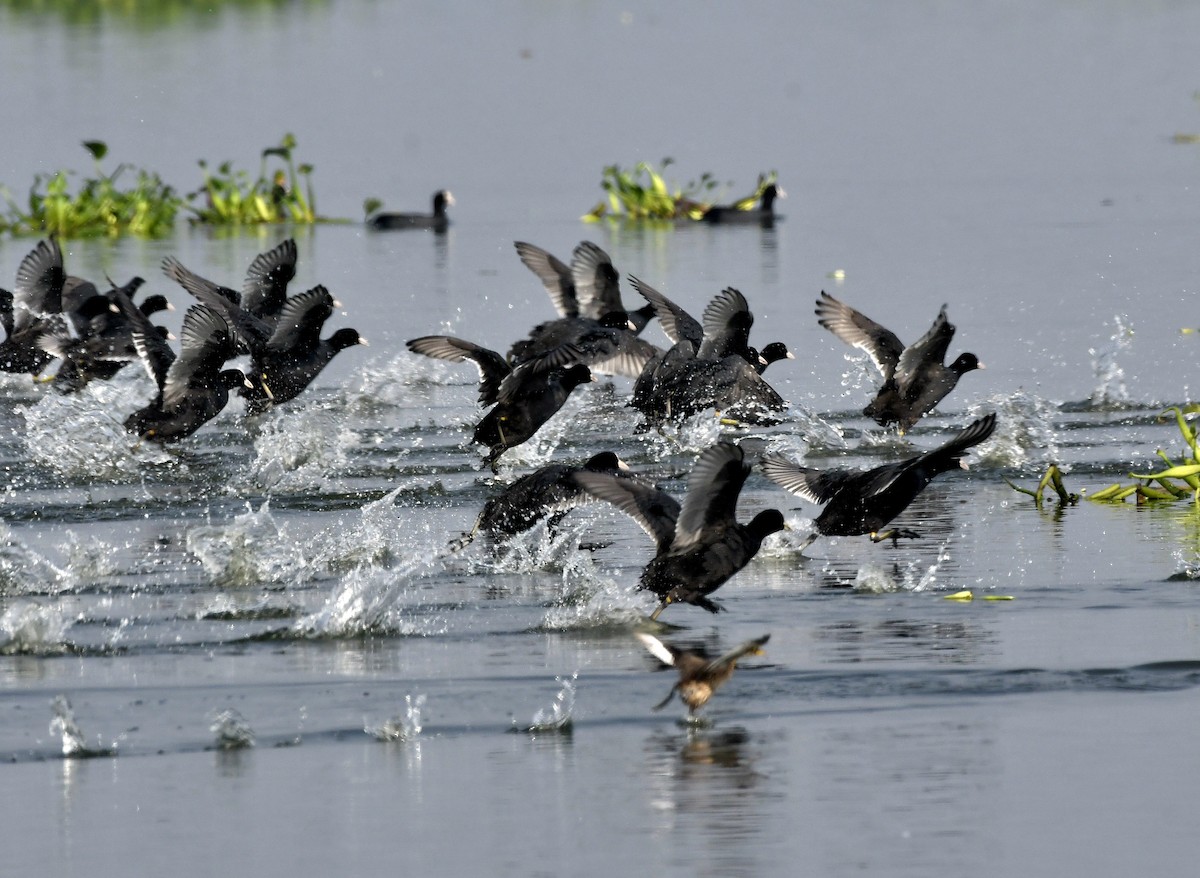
[188,133,318,225]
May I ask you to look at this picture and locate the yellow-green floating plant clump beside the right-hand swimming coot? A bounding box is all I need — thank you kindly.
[583,157,775,222]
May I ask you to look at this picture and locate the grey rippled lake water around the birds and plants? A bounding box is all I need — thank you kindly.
[0,0,1200,877]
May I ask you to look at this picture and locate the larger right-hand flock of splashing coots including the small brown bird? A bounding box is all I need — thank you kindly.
[407,241,996,714]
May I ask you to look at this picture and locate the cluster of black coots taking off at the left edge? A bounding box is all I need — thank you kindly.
[0,237,366,443]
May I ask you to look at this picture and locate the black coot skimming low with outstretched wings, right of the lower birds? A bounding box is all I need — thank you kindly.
[762,414,996,541]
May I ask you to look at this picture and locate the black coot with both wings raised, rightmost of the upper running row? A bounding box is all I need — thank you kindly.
[816,291,984,433]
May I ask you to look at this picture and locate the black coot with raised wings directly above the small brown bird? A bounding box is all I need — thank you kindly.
[575,443,785,619]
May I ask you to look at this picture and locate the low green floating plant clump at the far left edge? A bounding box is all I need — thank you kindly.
[0,140,184,237]
